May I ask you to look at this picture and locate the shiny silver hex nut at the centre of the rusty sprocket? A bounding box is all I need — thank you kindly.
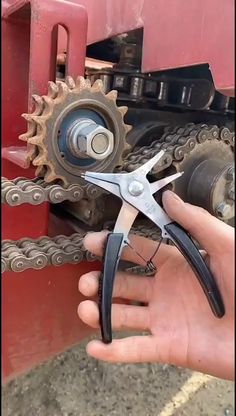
[68,119,114,160]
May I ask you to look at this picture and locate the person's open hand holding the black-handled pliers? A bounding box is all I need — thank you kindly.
[78,191,234,379]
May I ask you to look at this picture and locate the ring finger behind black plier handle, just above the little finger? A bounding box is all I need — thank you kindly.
[78,300,149,331]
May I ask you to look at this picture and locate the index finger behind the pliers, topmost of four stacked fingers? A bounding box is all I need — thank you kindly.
[84,231,175,266]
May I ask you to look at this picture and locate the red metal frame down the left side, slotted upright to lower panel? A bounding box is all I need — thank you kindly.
[2,0,93,380]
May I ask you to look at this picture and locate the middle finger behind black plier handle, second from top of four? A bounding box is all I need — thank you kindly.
[79,271,153,303]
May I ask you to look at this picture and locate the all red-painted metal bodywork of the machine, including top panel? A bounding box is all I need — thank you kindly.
[2,0,235,380]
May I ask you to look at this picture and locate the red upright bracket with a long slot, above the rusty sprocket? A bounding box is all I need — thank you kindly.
[2,0,87,168]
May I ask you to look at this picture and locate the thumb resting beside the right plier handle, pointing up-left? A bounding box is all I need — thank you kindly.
[163,191,234,254]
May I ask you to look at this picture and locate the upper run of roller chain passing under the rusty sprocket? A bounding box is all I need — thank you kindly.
[2,123,235,206]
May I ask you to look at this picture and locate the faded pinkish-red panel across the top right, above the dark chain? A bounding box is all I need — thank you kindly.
[62,0,235,96]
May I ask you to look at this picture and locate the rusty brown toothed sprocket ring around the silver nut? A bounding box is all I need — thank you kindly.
[19,77,131,185]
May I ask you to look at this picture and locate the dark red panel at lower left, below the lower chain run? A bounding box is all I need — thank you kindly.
[2,263,98,382]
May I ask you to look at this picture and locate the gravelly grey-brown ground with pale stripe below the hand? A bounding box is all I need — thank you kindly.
[2,338,235,416]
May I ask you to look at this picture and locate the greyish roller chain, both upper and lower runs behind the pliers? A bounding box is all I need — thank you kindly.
[2,123,234,272]
